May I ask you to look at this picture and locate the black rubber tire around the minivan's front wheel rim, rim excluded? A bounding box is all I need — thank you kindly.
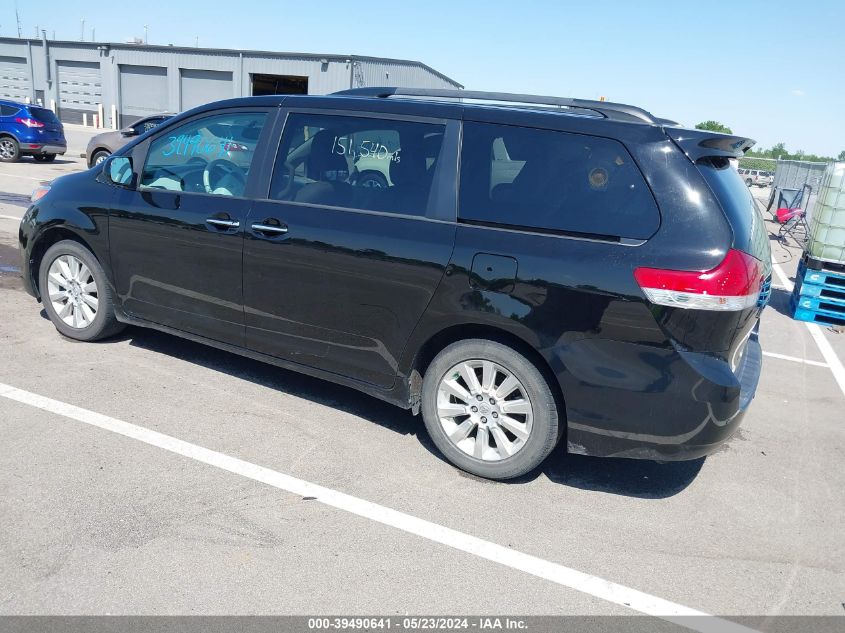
[38,240,125,341]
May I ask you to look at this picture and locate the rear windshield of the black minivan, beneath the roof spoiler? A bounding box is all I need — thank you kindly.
[696,158,772,266]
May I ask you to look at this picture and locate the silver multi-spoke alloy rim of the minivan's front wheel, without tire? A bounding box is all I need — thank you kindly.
[47,255,99,330]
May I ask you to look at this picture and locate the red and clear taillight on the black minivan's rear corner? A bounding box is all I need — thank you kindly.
[634,250,763,310]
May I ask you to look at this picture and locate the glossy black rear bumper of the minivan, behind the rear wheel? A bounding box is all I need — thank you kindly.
[558,334,762,461]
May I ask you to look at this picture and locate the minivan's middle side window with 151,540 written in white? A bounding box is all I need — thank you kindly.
[270,114,445,215]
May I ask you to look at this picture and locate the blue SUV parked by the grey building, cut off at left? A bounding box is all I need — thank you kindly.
[0,100,67,163]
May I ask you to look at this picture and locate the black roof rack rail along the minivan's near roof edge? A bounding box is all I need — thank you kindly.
[333,87,664,125]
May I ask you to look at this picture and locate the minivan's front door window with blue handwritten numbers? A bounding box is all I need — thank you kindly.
[140,113,267,196]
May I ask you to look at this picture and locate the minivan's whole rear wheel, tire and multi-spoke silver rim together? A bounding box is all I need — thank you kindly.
[422,339,560,479]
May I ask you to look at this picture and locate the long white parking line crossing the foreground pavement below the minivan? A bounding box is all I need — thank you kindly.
[0,383,753,633]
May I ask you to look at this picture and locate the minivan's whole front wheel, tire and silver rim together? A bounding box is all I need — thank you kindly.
[38,240,123,341]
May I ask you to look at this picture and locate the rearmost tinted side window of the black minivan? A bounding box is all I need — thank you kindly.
[459,122,660,239]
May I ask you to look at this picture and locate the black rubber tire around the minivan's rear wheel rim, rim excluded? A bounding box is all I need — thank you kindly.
[422,339,563,480]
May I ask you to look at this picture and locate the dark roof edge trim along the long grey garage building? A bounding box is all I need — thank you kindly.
[0,36,464,88]
